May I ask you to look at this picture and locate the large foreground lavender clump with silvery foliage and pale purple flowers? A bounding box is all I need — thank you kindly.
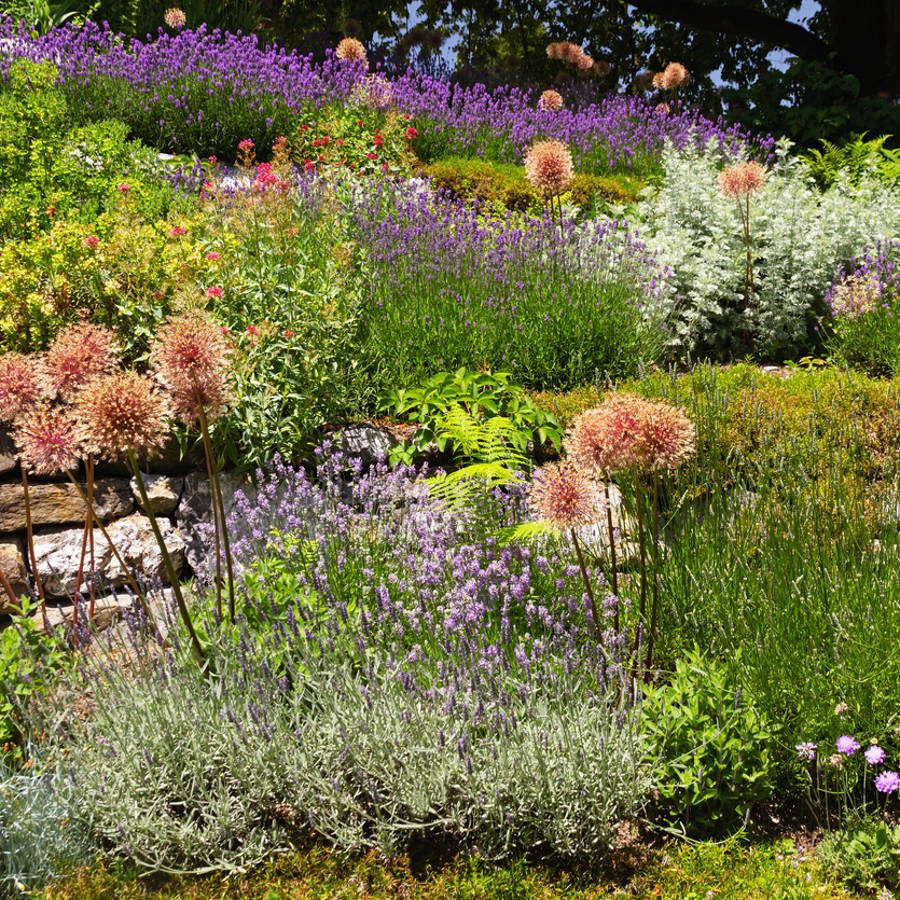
[35,446,649,871]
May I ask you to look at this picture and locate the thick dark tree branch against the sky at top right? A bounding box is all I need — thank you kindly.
[629,0,831,60]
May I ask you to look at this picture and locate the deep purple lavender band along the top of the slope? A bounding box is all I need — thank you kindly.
[0,20,768,172]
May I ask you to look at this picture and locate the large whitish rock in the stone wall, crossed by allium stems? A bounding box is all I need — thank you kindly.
[34,513,185,597]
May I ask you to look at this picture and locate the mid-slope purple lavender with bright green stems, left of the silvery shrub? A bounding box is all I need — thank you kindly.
[344,182,667,388]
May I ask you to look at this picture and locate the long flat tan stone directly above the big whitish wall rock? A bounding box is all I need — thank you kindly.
[0,479,134,532]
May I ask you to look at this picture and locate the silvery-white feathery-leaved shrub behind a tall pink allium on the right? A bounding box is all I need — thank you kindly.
[632,141,900,358]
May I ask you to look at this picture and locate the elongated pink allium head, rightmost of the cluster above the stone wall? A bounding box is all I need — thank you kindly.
[152,313,229,424]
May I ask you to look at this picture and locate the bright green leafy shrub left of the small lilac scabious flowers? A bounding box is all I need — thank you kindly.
[643,649,772,834]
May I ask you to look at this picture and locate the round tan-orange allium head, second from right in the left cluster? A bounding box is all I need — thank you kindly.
[74,372,166,459]
